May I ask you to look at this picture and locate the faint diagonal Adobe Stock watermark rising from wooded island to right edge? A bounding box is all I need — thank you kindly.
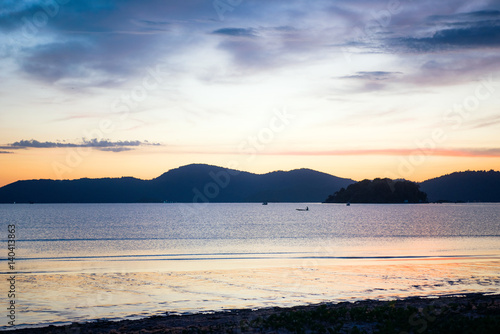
[385,74,498,179]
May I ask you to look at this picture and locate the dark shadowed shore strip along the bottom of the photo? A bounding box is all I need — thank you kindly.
[9,294,500,334]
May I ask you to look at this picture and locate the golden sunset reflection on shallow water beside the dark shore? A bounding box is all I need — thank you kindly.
[8,258,500,324]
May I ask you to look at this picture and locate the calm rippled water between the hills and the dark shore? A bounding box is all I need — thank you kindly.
[0,203,500,329]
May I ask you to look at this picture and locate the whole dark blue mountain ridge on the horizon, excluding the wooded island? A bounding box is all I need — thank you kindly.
[0,164,500,203]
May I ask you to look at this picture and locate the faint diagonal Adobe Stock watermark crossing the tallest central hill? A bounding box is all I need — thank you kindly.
[179,108,296,217]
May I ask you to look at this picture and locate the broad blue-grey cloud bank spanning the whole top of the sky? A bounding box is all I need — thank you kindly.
[0,0,500,89]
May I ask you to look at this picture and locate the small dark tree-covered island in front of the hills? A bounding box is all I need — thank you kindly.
[325,178,427,203]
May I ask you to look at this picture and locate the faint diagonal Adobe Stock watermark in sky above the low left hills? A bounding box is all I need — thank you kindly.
[52,64,169,179]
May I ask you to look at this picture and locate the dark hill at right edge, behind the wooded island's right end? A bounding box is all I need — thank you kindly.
[421,170,500,202]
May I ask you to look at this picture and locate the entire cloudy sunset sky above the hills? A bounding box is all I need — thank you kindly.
[0,0,500,186]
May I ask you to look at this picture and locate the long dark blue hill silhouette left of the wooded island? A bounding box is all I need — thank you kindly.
[0,164,354,203]
